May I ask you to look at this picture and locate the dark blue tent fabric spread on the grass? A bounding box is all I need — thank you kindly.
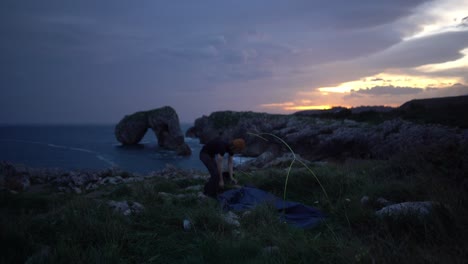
[218,187,325,228]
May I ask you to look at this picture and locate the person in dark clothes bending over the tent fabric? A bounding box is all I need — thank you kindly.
[200,138,245,198]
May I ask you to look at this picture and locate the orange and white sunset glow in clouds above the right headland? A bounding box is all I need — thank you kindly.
[260,1,468,113]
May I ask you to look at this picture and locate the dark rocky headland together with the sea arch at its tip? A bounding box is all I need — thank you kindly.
[115,95,468,166]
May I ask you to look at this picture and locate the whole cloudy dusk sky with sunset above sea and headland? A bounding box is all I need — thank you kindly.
[0,0,468,124]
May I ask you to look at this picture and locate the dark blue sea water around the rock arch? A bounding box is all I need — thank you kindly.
[0,124,205,173]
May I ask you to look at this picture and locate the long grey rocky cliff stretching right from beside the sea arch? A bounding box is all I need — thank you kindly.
[187,111,468,167]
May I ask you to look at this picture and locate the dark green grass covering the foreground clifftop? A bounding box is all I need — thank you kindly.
[0,154,468,263]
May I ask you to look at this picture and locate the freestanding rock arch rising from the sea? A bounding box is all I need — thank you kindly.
[115,106,191,156]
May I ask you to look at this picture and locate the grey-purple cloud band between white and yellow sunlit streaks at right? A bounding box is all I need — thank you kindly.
[290,28,468,92]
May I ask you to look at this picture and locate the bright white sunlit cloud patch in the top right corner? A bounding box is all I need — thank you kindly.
[404,0,468,40]
